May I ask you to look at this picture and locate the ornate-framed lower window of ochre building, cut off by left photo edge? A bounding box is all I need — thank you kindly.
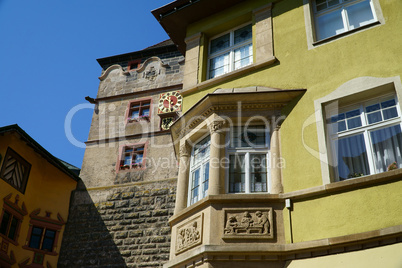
[0,194,28,245]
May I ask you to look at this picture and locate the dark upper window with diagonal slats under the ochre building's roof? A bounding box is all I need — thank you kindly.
[0,147,31,193]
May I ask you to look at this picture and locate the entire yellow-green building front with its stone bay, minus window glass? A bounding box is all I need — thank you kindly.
[154,0,402,267]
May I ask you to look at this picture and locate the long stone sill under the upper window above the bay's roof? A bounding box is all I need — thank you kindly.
[182,56,276,95]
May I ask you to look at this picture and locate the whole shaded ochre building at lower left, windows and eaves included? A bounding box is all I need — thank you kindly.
[0,125,78,267]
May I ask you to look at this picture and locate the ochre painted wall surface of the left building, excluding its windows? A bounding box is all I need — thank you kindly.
[0,134,77,267]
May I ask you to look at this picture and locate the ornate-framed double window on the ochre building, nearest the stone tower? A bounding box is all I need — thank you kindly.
[23,209,65,255]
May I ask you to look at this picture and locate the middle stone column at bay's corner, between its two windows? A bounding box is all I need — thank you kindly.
[208,118,225,195]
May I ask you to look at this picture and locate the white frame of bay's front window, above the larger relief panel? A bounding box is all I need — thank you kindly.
[225,125,271,194]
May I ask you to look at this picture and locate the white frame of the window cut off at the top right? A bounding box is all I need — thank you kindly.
[312,0,378,41]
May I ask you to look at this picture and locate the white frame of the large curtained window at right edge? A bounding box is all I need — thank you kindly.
[327,94,402,181]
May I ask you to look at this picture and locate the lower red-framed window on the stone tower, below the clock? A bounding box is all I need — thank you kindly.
[116,143,147,171]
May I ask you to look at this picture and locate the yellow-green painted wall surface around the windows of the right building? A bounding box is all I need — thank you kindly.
[180,0,402,242]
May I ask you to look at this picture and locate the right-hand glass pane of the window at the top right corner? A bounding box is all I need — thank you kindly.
[346,1,375,30]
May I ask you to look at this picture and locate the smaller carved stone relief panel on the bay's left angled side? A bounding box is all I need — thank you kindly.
[176,213,204,254]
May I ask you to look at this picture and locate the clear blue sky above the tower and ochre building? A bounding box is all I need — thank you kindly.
[0,0,171,167]
